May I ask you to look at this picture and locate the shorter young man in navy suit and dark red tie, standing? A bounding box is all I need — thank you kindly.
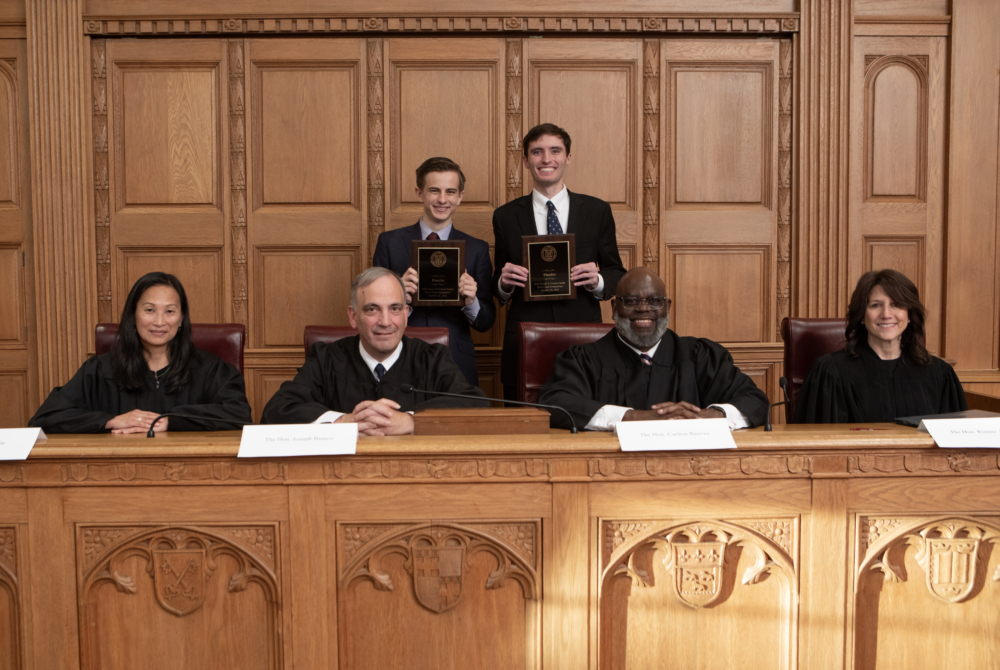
[372,157,496,386]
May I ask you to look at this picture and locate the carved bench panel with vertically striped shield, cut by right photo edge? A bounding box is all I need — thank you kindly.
[854,514,1000,670]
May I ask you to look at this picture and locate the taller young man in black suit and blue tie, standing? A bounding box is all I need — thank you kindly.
[492,123,625,400]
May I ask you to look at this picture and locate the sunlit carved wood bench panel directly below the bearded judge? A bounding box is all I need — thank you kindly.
[599,517,799,668]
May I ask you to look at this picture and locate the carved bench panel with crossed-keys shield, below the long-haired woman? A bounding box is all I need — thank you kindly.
[76,524,284,670]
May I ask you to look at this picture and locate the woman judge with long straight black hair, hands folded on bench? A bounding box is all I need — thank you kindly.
[29,272,253,433]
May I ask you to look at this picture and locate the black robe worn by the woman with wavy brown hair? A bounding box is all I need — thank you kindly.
[795,340,968,423]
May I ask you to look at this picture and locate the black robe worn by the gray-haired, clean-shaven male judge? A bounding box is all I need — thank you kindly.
[262,335,489,423]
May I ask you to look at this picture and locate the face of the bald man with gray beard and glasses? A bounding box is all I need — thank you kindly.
[612,267,670,351]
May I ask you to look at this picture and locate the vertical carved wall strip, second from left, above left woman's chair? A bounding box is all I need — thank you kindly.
[227,40,250,332]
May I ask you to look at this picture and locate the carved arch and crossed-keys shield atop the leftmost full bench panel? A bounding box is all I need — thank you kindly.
[78,526,281,628]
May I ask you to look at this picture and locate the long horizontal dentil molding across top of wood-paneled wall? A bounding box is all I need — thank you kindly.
[83,13,799,36]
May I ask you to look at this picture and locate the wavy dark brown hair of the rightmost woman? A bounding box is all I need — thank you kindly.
[844,269,931,365]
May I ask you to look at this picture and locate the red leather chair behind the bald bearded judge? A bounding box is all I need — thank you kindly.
[517,321,615,402]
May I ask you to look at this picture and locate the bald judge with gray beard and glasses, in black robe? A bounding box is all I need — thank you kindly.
[538,267,768,430]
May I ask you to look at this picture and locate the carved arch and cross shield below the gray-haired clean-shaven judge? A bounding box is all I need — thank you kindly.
[340,522,539,613]
